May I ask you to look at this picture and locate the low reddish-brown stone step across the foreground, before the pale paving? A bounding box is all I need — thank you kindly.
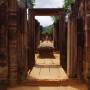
[23,79,69,86]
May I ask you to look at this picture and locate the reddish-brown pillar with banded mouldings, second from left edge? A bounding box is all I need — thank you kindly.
[8,0,17,85]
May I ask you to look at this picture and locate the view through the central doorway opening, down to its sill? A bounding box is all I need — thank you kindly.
[35,16,60,65]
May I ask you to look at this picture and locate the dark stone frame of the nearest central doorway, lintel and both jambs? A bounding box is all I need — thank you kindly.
[25,8,67,83]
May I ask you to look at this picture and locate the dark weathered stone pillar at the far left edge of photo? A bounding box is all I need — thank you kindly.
[0,2,8,90]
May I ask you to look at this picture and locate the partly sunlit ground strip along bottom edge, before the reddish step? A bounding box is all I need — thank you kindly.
[8,81,88,90]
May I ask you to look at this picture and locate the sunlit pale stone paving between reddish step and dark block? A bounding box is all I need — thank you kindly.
[28,54,68,81]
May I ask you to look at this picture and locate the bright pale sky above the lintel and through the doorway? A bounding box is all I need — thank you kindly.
[34,0,64,26]
